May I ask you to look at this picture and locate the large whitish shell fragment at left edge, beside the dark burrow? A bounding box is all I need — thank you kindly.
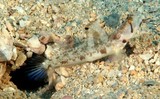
[0,29,13,62]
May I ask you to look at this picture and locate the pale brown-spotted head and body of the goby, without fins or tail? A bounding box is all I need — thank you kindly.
[45,14,143,68]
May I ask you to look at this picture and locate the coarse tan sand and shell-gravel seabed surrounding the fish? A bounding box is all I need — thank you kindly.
[0,0,160,99]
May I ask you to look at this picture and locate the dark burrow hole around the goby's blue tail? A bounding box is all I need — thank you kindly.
[10,54,48,92]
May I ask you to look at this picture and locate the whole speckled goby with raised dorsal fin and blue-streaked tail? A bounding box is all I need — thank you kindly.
[27,14,143,82]
